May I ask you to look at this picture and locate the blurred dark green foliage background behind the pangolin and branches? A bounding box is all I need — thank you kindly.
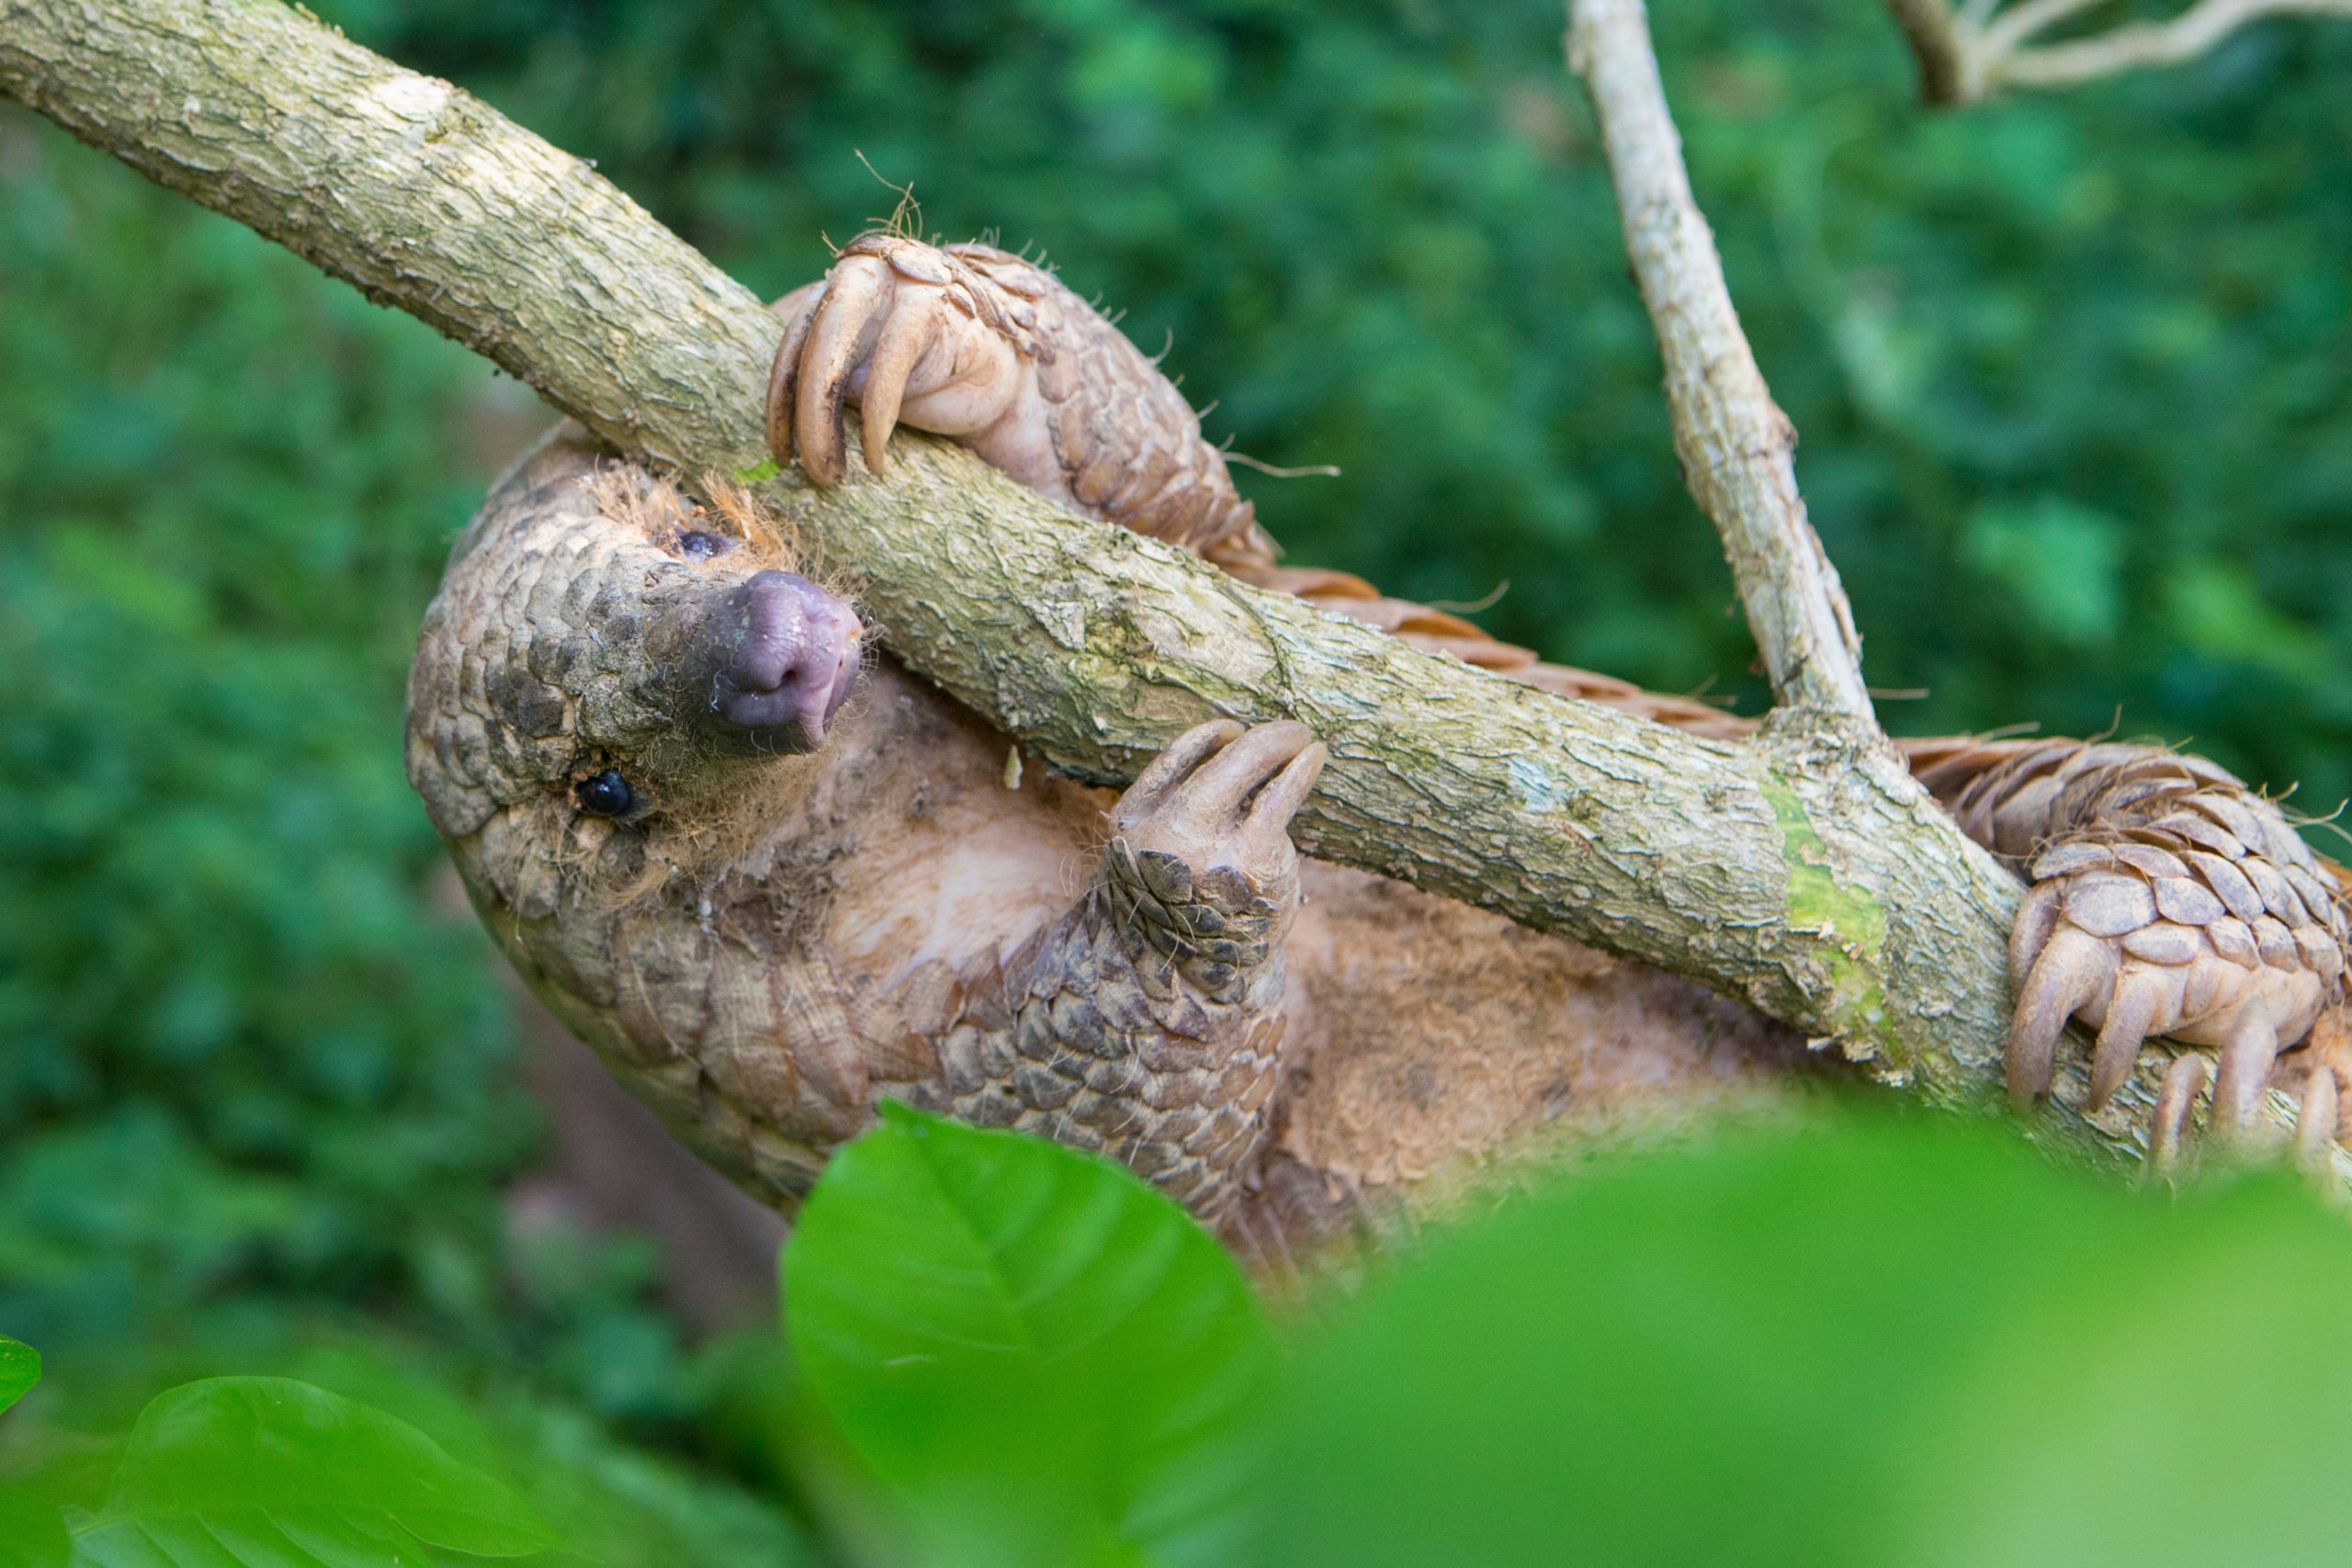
[0,0,2352,1532]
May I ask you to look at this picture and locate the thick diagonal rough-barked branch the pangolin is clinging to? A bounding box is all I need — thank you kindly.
[0,0,2324,1170]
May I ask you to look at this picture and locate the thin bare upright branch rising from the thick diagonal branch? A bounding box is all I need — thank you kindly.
[1569,0,1877,731]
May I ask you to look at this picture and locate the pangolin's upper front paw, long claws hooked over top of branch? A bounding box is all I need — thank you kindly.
[767,232,1025,487]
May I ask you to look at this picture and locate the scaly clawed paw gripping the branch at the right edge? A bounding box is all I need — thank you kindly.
[2008,831,2345,1143]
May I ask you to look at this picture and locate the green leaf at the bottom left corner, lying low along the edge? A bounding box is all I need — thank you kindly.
[75,1378,562,1568]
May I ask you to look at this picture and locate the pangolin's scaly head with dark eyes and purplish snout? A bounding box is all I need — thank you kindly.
[407,425,864,915]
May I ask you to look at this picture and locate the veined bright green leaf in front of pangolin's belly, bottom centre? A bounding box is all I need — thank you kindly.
[783,1105,1272,1563]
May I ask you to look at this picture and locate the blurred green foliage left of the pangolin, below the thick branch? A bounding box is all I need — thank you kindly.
[0,95,686,1405]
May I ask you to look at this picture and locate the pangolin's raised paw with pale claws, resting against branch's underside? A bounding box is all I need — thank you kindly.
[1103,719,1329,968]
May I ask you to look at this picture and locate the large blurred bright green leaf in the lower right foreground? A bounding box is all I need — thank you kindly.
[1261,1123,2352,1568]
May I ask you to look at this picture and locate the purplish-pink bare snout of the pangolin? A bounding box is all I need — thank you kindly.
[710,571,865,752]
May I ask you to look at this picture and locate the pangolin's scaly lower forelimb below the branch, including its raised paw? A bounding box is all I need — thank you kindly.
[917,719,1324,1224]
